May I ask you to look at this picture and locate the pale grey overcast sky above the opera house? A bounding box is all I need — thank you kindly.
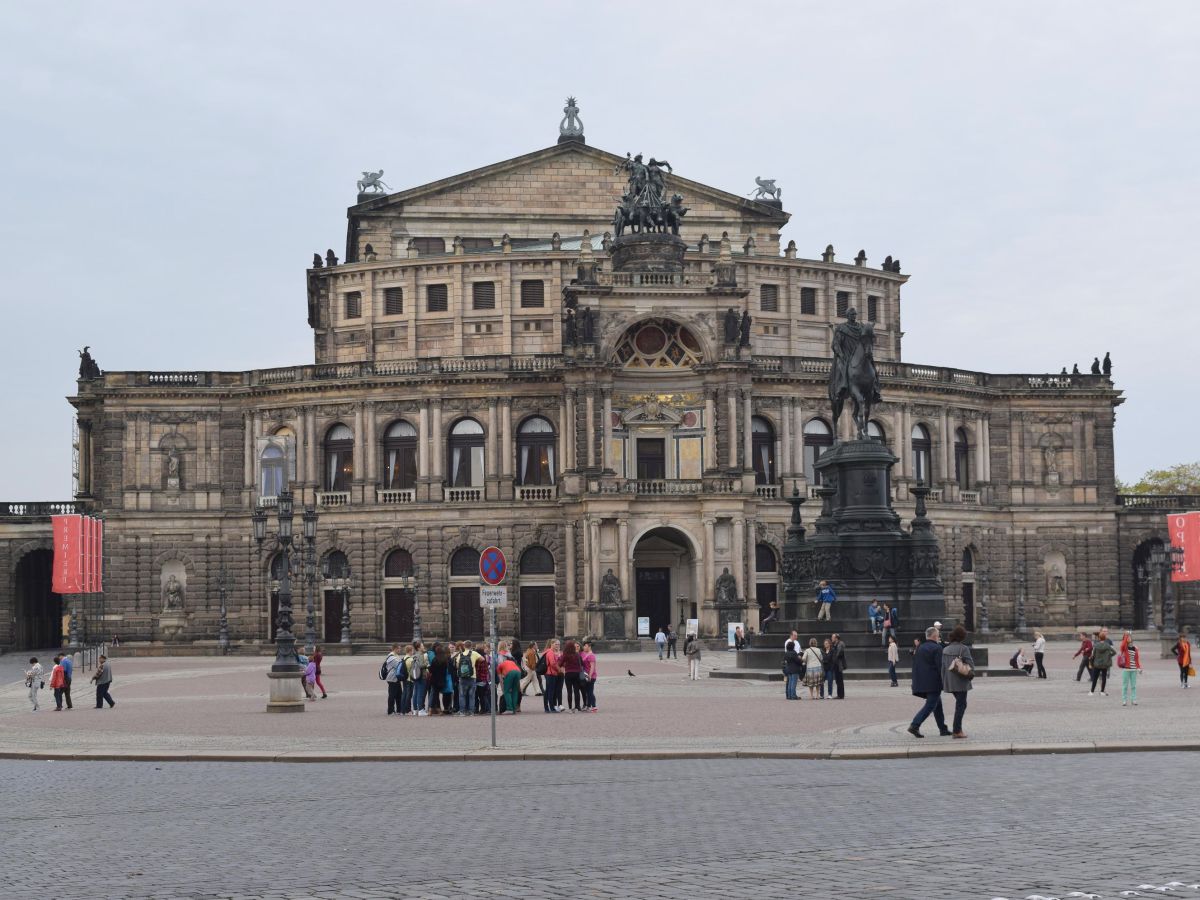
[0,0,1200,500]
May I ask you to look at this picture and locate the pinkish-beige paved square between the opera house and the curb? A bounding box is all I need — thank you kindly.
[0,644,1200,754]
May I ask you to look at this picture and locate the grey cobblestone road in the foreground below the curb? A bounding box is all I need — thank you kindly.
[0,754,1200,900]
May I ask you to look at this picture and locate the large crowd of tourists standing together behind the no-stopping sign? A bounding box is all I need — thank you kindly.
[379,640,598,716]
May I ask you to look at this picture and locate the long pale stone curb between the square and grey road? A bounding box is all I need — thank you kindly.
[0,740,1200,763]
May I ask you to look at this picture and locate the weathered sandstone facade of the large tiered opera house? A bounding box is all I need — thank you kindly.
[0,132,1195,646]
